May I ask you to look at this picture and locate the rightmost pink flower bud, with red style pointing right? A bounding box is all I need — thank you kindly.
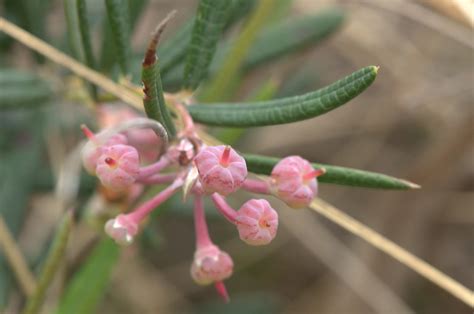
[271,156,324,208]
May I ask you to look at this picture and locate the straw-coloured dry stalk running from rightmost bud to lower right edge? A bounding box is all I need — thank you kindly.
[310,199,474,307]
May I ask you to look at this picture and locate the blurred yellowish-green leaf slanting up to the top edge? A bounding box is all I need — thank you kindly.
[201,0,276,102]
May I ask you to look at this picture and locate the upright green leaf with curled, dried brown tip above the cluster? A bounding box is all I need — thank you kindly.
[142,12,176,138]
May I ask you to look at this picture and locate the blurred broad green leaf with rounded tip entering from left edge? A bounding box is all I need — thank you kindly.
[0,69,52,110]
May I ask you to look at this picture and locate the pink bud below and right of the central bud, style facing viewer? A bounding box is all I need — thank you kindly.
[236,199,278,245]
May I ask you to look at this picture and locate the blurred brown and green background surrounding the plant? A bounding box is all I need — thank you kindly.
[0,0,474,314]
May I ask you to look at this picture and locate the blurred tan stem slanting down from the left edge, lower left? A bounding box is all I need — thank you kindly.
[0,214,36,296]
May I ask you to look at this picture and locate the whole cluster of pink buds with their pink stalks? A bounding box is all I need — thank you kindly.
[82,105,324,300]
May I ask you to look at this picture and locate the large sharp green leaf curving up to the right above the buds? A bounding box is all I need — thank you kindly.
[188,66,378,127]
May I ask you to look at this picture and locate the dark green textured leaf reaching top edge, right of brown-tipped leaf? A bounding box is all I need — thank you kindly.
[183,0,231,90]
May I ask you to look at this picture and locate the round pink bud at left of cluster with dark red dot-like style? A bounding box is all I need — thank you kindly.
[96,144,140,191]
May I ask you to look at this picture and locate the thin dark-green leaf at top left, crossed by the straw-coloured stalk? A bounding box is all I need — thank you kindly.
[76,0,97,98]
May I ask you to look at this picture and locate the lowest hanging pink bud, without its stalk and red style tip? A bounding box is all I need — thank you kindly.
[191,244,234,285]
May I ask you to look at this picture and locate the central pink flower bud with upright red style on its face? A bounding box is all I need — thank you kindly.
[194,145,247,195]
